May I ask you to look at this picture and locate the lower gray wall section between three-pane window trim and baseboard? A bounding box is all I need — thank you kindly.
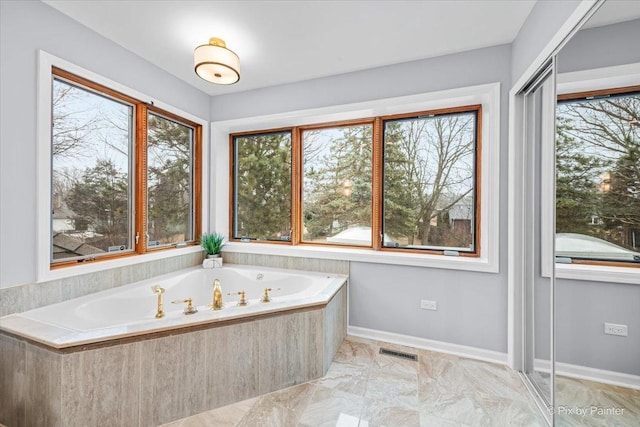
[349,262,507,352]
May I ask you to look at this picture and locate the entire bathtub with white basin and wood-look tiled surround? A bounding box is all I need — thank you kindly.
[0,264,348,427]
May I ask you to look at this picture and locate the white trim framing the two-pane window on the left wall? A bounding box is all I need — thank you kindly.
[36,50,210,283]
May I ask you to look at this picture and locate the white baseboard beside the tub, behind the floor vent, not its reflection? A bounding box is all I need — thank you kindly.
[347,326,507,365]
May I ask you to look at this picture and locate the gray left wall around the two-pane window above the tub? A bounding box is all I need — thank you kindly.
[0,0,209,287]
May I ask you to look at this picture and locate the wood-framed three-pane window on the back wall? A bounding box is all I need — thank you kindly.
[231,105,481,256]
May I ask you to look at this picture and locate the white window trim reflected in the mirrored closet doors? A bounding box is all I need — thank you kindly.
[541,63,640,285]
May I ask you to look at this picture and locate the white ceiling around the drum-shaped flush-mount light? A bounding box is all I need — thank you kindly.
[43,0,535,95]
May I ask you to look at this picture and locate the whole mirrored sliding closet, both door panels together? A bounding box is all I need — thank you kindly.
[510,0,640,426]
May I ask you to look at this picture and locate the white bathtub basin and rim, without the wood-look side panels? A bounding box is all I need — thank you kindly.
[0,265,346,349]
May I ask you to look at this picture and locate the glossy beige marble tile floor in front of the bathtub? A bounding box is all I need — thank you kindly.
[164,337,639,427]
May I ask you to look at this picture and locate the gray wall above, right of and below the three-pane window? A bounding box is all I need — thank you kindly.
[211,45,511,352]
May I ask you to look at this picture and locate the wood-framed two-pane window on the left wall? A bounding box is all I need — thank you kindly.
[50,67,201,266]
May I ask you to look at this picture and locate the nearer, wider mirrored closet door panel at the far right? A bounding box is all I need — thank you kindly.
[554,0,640,426]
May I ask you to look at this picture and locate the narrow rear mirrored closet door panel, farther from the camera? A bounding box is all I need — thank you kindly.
[522,61,555,421]
